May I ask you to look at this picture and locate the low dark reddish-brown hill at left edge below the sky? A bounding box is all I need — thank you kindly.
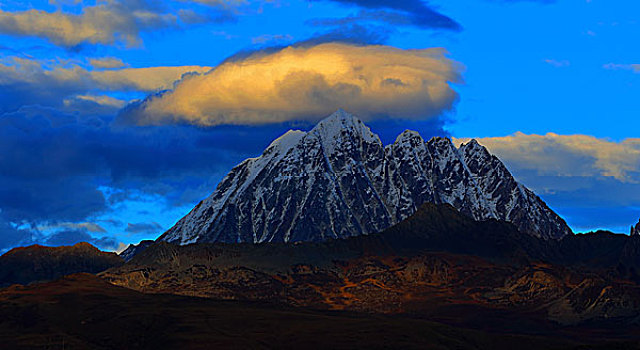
[0,243,124,286]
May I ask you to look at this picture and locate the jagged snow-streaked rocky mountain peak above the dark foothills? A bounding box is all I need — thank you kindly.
[159,110,571,244]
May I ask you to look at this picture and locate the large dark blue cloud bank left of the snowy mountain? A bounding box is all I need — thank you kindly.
[0,108,287,225]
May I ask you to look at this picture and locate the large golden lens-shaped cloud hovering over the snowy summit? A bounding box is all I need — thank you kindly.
[121,43,461,125]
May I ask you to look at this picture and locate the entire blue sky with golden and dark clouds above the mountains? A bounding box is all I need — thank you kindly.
[0,0,640,250]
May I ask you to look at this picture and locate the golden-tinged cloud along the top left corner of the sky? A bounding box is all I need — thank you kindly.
[0,0,244,48]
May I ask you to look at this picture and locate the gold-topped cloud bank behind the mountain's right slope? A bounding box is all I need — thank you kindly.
[454,133,640,233]
